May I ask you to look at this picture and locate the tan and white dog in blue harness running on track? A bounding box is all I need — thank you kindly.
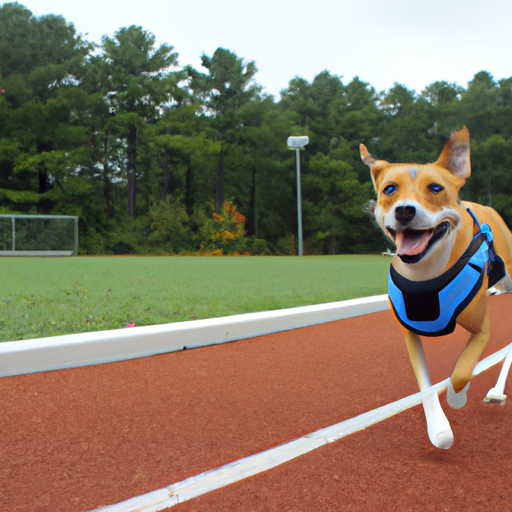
[360,127,512,449]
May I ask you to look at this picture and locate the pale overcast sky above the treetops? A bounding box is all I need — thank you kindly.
[6,0,512,99]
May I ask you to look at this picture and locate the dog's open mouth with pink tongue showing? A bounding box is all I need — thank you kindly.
[388,220,450,263]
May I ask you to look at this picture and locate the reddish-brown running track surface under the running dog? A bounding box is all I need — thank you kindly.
[0,296,512,512]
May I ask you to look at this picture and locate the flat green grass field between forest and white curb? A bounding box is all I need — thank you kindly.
[0,256,390,341]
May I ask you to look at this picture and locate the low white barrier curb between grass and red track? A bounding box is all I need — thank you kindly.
[0,295,389,377]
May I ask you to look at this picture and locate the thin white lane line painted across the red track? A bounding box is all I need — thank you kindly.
[95,343,512,512]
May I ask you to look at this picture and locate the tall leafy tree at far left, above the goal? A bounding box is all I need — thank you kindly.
[0,3,91,211]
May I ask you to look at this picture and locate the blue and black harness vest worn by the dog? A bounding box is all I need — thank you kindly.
[388,208,506,336]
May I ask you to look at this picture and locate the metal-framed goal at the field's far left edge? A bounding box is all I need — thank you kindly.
[0,214,78,256]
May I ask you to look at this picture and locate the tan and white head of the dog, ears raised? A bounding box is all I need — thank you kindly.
[360,127,471,264]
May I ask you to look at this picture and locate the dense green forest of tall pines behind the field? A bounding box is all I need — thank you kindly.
[0,3,512,255]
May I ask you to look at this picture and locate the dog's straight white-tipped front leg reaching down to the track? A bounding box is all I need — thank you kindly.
[405,331,453,450]
